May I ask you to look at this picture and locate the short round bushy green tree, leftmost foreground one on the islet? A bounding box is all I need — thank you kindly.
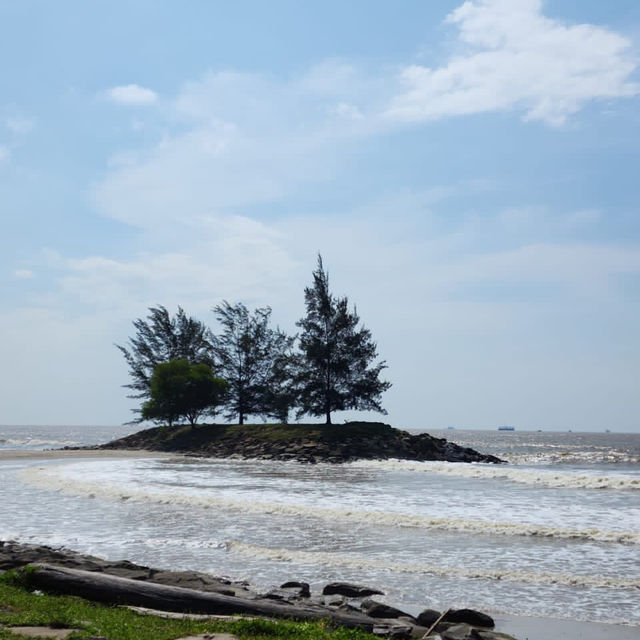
[141,358,228,426]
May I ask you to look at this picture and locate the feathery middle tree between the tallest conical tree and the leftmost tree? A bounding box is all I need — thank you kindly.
[213,300,293,424]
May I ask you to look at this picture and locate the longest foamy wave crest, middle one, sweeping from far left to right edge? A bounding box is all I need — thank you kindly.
[18,465,640,545]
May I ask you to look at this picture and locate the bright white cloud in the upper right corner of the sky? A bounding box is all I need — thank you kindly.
[387,0,640,125]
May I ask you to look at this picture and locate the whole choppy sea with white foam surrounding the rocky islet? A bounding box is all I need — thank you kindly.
[0,426,640,635]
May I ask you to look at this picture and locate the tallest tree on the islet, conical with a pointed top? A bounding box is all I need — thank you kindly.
[296,255,391,424]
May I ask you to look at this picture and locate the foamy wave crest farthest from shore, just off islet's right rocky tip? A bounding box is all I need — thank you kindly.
[349,460,640,491]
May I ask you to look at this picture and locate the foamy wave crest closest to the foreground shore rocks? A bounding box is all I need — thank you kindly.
[228,541,640,589]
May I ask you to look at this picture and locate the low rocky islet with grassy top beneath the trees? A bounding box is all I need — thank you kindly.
[87,422,504,464]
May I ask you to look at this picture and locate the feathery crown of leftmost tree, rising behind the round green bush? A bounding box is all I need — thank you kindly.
[116,306,213,408]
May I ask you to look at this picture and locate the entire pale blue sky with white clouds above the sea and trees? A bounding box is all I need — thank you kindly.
[0,0,640,432]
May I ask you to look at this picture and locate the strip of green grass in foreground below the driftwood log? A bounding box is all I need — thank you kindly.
[0,572,374,640]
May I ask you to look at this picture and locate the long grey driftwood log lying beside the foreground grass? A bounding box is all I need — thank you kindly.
[29,564,376,631]
